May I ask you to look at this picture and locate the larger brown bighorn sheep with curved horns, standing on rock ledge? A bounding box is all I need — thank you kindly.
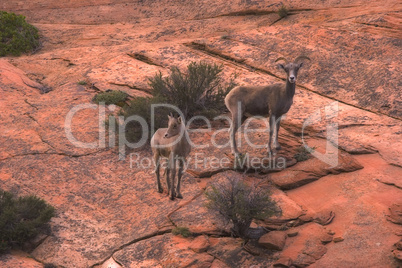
[225,56,310,156]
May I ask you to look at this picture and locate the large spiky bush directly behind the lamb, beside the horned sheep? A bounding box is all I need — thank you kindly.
[149,62,235,118]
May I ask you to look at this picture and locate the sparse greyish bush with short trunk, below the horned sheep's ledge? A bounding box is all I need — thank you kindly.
[205,177,280,238]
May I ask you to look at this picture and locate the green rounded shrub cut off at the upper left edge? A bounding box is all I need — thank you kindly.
[0,11,39,57]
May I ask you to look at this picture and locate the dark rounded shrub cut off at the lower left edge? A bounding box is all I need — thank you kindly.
[0,190,54,252]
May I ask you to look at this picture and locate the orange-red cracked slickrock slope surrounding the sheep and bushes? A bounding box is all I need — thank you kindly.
[0,0,402,267]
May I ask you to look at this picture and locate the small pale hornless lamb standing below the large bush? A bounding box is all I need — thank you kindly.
[151,114,191,200]
